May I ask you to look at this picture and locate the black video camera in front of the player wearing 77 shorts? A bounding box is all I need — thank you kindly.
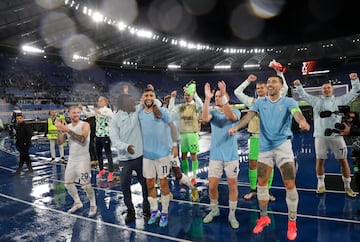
[320,105,359,136]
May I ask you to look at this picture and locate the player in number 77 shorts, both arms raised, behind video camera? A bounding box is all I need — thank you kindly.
[294,73,360,198]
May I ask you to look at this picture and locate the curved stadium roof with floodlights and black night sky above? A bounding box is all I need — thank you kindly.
[0,0,360,71]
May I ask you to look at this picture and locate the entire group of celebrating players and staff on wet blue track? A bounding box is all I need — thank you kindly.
[16,61,360,240]
